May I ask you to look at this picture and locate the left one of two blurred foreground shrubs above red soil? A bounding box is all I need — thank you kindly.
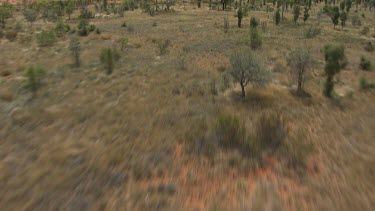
[214,114,246,147]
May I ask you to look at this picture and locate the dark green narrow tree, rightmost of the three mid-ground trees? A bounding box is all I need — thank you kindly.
[324,44,347,97]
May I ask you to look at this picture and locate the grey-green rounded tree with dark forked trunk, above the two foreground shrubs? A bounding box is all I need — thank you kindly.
[229,49,269,97]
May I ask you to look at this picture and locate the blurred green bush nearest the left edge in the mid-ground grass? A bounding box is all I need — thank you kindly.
[24,65,46,94]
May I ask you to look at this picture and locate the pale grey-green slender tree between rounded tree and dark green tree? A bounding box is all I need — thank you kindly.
[287,48,312,95]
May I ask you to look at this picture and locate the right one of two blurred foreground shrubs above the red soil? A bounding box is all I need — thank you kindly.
[255,112,287,150]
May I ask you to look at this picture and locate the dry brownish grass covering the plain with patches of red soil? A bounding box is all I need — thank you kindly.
[0,2,375,210]
